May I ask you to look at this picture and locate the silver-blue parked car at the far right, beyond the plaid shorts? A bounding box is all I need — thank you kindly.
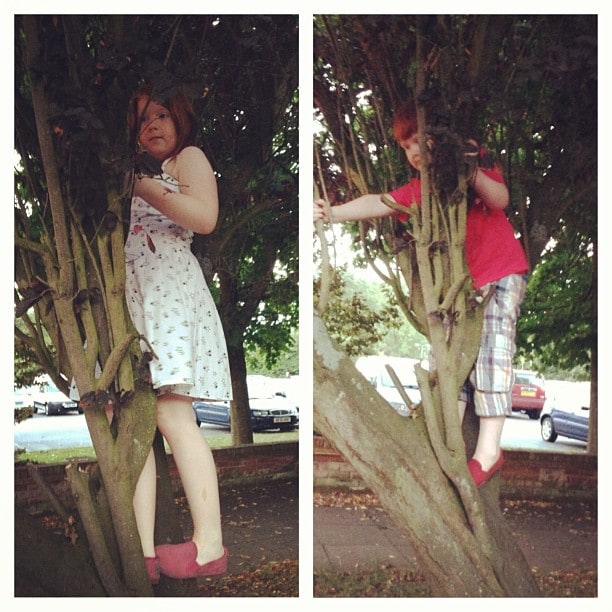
[540,383,591,442]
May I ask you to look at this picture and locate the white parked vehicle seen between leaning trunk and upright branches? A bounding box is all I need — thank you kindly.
[355,355,421,416]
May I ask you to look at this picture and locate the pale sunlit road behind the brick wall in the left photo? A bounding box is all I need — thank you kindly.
[14,413,230,451]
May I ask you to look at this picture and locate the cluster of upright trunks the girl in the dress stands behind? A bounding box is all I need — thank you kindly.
[23,15,157,596]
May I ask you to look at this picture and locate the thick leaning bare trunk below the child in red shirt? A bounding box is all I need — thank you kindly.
[314,318,538,597]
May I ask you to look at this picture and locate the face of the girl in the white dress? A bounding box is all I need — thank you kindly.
[137,98,178,162]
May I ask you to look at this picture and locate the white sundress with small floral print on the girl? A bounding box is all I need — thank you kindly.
[125,169,232,400]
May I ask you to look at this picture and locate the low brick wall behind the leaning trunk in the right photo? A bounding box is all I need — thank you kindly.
[313,435,597,501]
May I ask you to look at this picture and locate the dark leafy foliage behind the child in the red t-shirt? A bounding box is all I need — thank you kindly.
[314,15,597,378]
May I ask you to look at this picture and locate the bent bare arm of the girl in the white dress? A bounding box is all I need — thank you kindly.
[134,147,219,234]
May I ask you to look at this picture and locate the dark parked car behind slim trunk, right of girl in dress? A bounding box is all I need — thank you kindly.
[193,375,299,431]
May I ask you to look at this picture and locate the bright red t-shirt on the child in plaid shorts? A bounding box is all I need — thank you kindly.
[389,168,529,289]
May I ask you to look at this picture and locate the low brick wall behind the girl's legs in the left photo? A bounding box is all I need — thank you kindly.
[15,442,299,514]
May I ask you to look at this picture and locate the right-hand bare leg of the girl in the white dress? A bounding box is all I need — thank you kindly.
[157,394,223,565]
